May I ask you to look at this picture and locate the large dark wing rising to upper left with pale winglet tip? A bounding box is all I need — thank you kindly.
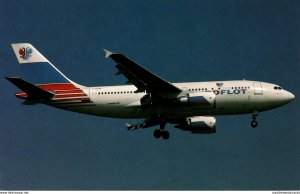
[104,49,182,98]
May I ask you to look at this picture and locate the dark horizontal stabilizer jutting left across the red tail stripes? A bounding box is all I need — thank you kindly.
[6,77,54,100]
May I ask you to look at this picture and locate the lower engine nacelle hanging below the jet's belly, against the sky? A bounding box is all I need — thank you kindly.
[175,116,216,133]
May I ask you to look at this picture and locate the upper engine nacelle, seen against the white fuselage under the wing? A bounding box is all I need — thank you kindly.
[179,92,216,109]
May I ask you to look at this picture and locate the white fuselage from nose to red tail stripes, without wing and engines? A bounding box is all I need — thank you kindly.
[62,80,294,118]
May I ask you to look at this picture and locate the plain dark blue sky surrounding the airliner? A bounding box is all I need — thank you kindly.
[0,0,300,190]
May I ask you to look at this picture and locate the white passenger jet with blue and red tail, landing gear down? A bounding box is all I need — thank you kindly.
[6,43,295,139]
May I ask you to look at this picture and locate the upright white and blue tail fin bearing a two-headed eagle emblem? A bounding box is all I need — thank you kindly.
[11,43,77,85]
